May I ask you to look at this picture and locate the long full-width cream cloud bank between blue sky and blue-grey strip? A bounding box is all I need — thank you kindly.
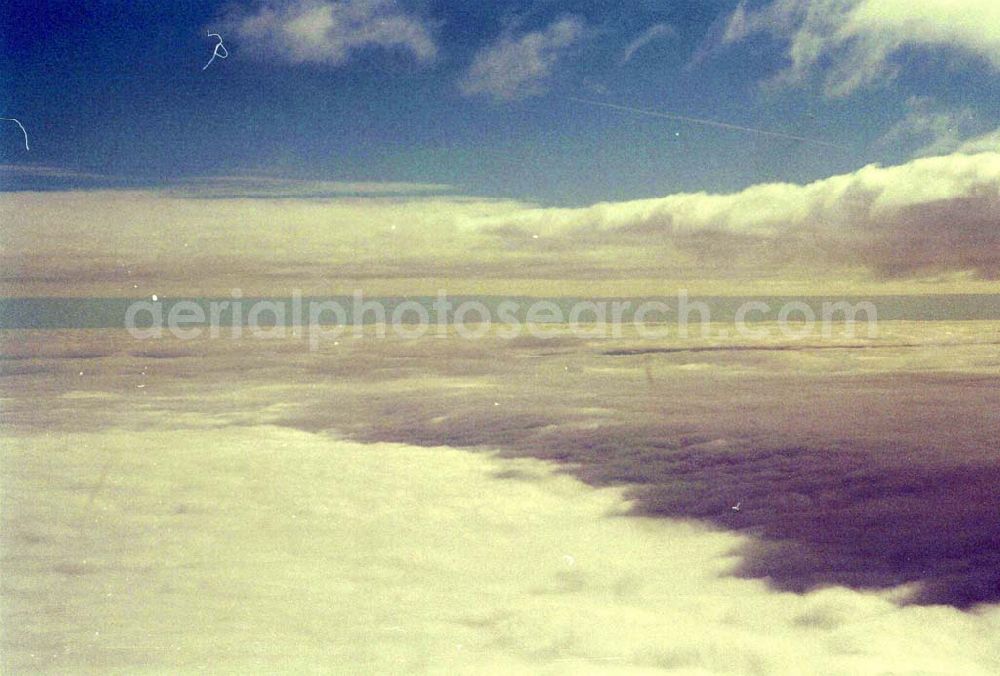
[0,148,1000,295]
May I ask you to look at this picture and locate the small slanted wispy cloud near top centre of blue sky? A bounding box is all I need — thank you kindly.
[459,16,585,100]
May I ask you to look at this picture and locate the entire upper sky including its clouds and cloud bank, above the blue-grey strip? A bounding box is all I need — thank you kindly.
[0,0,1000,294]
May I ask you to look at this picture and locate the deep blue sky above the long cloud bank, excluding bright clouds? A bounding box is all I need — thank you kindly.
[0,0,1000,206]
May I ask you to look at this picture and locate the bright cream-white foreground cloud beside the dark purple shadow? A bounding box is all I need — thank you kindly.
[4,420,1000,674]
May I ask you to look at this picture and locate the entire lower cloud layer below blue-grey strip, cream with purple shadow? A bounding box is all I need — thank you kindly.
[0,332,1000,675]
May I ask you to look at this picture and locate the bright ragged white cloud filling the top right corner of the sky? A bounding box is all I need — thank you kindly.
[723,0,1000,97]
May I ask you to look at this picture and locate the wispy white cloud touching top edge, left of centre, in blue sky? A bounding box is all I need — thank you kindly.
[228,0,437,66]
